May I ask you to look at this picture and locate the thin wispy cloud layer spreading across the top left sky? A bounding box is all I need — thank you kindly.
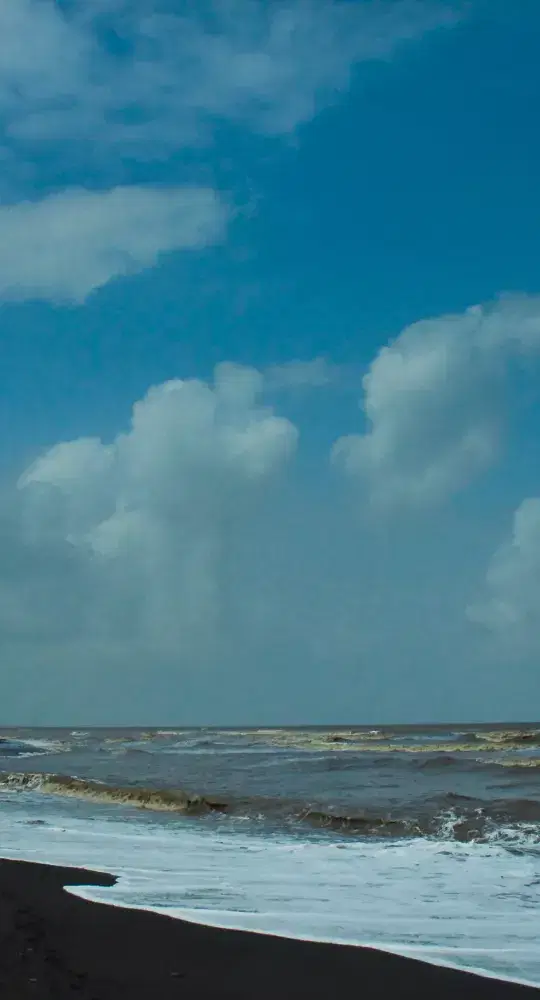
[0,0,456,157]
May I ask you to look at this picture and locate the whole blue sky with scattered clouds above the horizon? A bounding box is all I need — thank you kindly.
[0,0,540,726]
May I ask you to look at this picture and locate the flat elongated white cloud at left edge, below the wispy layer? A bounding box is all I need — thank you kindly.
[0,187,228,303]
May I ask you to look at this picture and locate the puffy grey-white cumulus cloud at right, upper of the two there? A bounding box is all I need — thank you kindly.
[333,296,540,504]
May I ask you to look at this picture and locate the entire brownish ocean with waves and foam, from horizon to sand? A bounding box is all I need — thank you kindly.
[0,723,540,986]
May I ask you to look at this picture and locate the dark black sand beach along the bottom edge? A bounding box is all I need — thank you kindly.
[0,861,538,1000]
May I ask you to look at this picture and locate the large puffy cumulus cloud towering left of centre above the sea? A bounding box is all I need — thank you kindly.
[12,365,297,664]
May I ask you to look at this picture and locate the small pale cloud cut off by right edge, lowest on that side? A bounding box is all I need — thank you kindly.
[467,497,540,648]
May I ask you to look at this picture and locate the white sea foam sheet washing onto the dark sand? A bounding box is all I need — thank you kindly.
[0,792,540,986]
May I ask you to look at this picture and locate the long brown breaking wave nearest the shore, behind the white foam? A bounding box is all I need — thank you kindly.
[4,772,540,843]
